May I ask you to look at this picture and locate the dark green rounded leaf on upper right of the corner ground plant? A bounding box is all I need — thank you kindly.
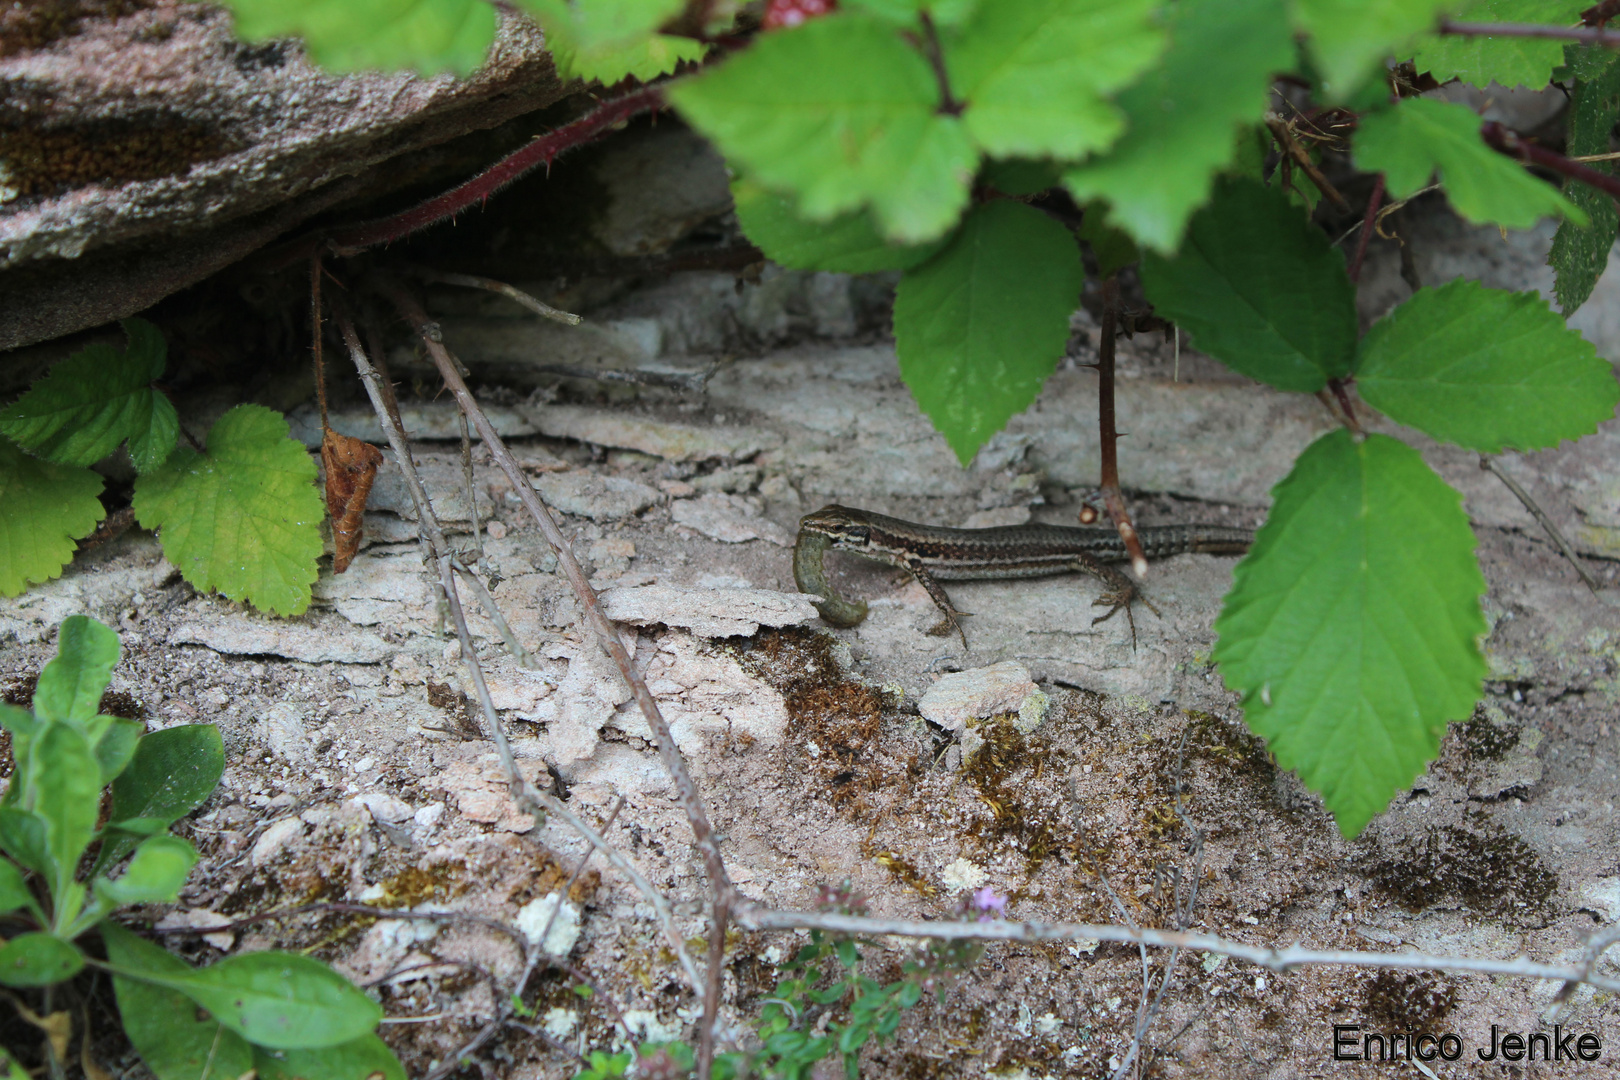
[92,724,225,874]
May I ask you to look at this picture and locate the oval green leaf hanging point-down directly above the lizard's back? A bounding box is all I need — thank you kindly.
[894,199,1085,465]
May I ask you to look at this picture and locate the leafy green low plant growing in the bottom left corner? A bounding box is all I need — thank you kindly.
[0,615,405,1080]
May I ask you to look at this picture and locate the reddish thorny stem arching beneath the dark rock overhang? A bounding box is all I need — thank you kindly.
[327,84,664,256]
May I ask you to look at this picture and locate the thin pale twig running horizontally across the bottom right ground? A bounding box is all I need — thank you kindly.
[732,904,1620,993]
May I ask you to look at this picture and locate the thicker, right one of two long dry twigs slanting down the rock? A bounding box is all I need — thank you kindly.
[379,279,734,919]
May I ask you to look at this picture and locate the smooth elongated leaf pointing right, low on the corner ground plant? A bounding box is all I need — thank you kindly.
[115,952,382,1049]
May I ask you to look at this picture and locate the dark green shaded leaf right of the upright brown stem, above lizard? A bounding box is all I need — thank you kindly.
[1142,180,1356,393]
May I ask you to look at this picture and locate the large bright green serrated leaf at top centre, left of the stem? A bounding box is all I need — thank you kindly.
[669,15,978,243]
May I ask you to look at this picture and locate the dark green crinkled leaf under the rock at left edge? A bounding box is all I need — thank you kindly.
[0,319,180,473]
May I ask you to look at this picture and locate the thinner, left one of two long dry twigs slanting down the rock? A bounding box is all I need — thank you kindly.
[337,299,701,994]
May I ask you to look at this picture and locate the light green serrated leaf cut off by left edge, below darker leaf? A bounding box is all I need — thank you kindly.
[0,439,107,596]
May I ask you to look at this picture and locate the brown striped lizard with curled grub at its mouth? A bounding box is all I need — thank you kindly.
[794,505,1254,648]
